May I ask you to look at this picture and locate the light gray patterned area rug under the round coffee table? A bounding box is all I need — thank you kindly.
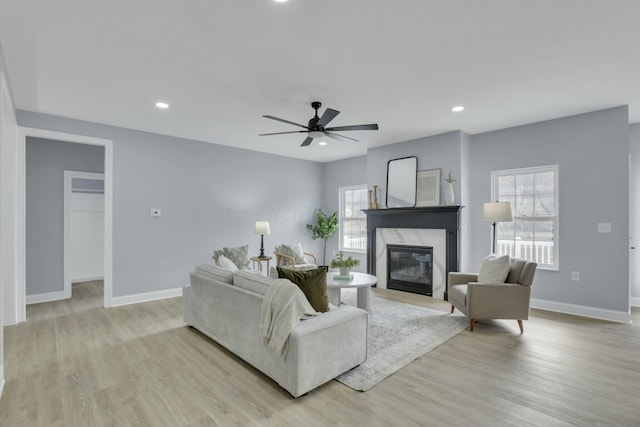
[336,289,469,391]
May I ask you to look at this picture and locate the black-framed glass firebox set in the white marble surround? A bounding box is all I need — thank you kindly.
[387,245,433,296]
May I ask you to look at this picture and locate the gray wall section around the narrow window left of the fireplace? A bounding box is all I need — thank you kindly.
[322,156,371,272]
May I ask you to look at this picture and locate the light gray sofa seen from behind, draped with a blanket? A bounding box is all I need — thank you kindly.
[183,265,367,397]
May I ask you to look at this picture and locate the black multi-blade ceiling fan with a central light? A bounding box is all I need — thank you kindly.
[259,101,378,147]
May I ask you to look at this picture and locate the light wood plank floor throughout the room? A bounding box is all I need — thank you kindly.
[0,283,640,427]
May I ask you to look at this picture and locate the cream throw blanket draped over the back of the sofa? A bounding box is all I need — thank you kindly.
[260,279,320,357]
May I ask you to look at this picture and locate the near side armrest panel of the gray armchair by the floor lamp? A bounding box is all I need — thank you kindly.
[466,283,531,320]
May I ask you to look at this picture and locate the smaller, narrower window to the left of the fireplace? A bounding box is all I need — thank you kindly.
[339,185,368,252]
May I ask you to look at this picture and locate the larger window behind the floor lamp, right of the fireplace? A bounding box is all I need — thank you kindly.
[491,165,558,269]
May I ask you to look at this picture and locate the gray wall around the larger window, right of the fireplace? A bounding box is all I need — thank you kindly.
[468,106,629,312]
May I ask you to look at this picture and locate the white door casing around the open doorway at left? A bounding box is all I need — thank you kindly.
[16,126,113,323]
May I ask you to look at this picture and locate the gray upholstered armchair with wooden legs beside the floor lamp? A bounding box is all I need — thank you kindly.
[449,255,537,333]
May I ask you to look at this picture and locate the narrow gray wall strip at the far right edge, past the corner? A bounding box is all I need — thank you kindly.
[629,123,640,307]
